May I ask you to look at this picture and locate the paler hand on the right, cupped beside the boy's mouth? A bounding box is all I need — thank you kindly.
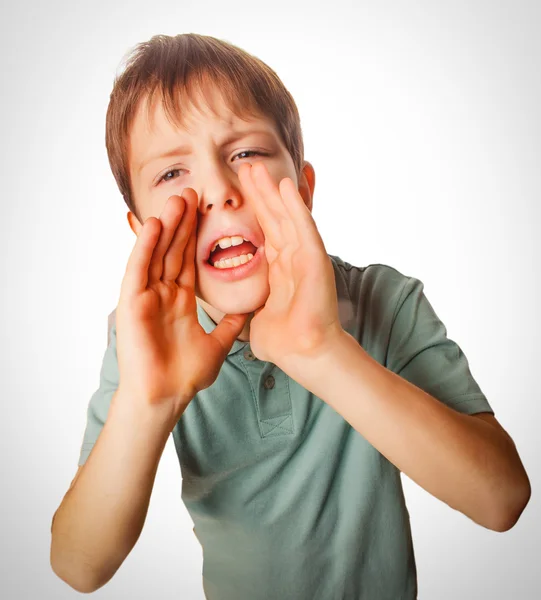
[238,163,343,376]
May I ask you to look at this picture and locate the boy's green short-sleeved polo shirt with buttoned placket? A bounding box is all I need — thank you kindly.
[79,256,494,600]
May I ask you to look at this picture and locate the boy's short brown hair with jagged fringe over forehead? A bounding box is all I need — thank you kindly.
[105,33,304,222]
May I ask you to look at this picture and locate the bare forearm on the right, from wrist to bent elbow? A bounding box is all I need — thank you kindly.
[299,336,524,529]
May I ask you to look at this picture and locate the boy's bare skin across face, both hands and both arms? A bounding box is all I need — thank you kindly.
[51,75,531,592]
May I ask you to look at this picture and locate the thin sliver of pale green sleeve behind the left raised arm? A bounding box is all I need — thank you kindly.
[78,311,119,466]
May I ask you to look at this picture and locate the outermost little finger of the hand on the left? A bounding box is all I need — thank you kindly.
[121,217,162,296]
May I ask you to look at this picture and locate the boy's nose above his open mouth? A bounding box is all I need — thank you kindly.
[198,160,242,215]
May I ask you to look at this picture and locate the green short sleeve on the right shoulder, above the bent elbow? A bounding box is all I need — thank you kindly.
[387,277,494,414]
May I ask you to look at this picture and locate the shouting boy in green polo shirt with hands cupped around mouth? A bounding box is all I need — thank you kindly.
[51,34,530,600]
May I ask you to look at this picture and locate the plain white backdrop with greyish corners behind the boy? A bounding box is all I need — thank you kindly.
[0,0,541,600]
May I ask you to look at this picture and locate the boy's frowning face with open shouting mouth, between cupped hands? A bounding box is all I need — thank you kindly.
[128,84,315,322]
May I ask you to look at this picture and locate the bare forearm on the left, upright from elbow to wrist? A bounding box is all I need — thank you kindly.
[51,388,182,592]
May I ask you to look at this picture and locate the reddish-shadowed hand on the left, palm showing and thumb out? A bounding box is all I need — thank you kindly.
[116,188,247,423]
